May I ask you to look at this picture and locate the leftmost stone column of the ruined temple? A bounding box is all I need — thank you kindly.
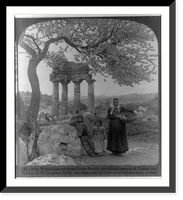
[52,80,59,118]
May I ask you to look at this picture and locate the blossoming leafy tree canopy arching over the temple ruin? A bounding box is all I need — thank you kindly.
[19,18,158,86]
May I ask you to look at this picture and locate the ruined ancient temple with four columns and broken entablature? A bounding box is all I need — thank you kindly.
[50,60,96,117]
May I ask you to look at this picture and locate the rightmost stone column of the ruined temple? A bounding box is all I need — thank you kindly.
[86,79,96,112]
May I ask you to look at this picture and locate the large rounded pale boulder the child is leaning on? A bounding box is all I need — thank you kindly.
[38,124,84,157]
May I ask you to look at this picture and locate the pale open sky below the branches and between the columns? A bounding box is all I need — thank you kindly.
[18,40,158,99]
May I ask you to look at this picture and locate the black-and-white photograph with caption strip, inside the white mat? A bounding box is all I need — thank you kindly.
[15,15,161,177]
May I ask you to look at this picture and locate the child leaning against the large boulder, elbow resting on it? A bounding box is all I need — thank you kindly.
[69,115,95,157]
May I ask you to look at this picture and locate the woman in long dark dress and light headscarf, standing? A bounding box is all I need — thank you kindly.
[107,98,134,156]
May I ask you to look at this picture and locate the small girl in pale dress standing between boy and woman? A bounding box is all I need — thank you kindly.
[91,119,106,156]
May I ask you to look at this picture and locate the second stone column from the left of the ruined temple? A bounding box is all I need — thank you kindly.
[60,80,70,115]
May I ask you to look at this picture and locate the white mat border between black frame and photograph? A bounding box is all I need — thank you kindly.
[6,6,169,187]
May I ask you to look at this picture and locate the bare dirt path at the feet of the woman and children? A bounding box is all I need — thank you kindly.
[74,138,159,165]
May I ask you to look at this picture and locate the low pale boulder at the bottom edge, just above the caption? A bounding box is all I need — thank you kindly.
[26,153,76,166]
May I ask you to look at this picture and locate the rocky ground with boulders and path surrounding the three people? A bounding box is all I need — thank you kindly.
[16,110,160,165]
